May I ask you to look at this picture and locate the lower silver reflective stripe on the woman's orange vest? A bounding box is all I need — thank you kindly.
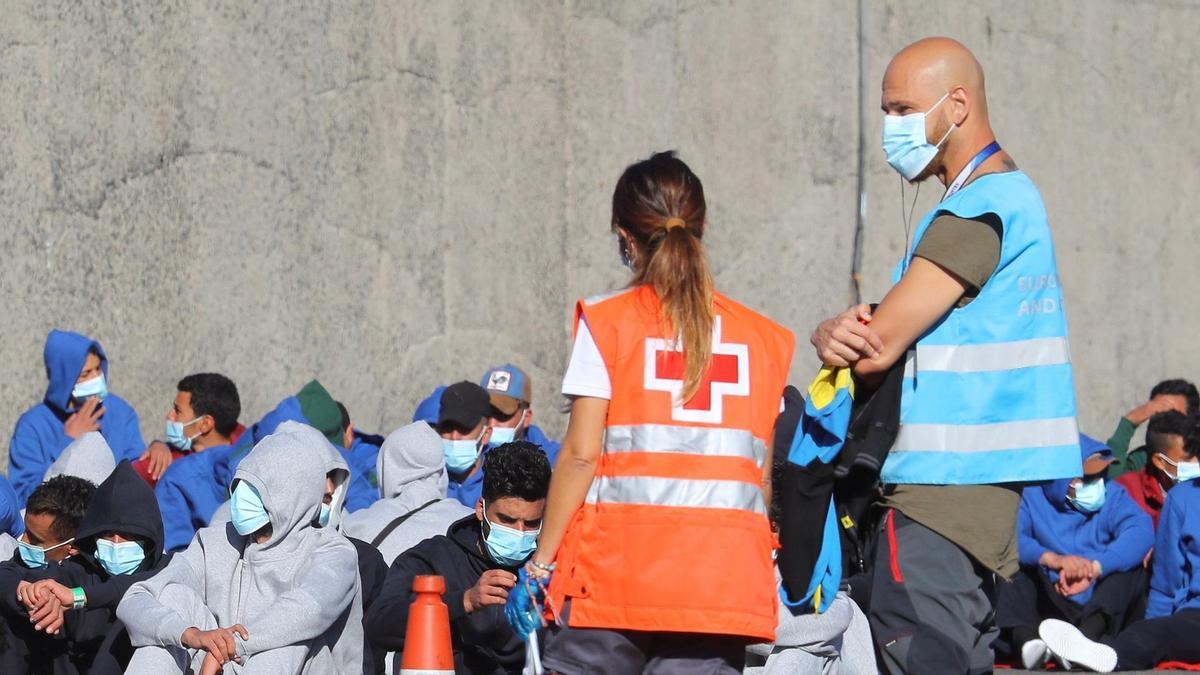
[587,476,767,514]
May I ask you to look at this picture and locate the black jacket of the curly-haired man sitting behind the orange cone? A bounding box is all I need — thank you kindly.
[364,514,524,675]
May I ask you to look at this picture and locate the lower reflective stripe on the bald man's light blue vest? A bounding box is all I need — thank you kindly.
[892,417,1079,453]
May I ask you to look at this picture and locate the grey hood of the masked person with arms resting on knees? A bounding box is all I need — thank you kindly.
[229,423,329,550]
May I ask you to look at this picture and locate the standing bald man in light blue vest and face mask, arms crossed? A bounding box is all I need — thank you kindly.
[812,37,1081,673]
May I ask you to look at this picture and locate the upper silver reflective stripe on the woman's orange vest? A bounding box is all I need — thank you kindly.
[604,424,767,466]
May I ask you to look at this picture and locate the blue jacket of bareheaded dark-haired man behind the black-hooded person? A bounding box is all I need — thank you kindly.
[154,441,236,551]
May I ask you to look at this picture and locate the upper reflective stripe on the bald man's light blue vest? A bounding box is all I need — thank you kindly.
[905,338,1070,377]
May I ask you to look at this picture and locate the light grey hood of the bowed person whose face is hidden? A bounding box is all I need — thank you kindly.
[376,422,449,499]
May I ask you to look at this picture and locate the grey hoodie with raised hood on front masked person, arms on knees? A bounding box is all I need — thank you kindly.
[116,417,362,675]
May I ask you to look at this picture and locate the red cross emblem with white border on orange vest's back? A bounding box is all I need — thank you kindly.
[644,316,750,424]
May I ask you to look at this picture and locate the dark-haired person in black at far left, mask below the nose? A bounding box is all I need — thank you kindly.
[0,476,96,674]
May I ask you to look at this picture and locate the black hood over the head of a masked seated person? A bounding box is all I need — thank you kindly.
[76,456,166,569]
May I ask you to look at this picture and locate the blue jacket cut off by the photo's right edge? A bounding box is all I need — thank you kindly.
[1146,480,1200,619]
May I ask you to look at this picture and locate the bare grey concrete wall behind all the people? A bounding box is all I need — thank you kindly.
[0,0,1200,468]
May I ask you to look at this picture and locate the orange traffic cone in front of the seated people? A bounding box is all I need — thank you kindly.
[400,575,454,675]
